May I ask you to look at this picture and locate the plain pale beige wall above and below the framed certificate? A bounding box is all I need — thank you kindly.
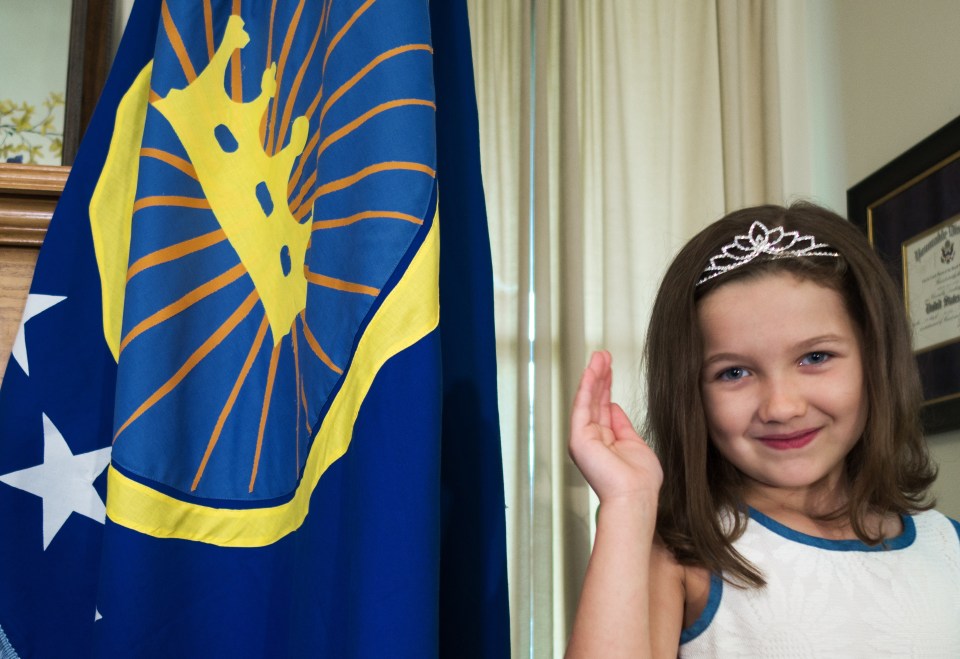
[800,0,960,519]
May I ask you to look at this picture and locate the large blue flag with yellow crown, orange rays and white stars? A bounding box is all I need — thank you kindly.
[0,0,509,659]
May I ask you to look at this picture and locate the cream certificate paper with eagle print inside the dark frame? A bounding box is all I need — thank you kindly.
[903,215,960,352]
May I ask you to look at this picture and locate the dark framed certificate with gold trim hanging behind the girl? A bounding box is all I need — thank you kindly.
[847,113,960,433]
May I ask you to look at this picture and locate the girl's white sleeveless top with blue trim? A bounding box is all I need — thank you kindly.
[679,510,960,659]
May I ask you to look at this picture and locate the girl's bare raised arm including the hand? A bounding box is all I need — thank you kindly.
[567,352,683,658]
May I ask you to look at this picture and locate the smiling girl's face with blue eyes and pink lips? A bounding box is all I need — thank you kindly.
[697,273,867,502]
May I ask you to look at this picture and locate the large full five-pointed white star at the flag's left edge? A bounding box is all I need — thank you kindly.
[0,414,111,550]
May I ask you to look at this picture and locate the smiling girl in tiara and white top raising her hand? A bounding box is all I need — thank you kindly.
[568,204,960,658]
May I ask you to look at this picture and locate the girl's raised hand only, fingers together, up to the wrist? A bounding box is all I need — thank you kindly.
[570,351,663,502]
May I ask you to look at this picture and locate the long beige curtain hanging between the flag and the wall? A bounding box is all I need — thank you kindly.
[468,0,782,657]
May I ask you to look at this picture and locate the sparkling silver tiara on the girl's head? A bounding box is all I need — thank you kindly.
[697,222,840,286]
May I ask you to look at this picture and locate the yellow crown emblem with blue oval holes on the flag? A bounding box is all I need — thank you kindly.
[153,16,311,345]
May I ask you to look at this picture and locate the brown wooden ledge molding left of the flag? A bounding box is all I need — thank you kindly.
[0,163,70,248]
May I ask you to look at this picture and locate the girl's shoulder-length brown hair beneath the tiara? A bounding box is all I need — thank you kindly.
[644,202,936,586]
